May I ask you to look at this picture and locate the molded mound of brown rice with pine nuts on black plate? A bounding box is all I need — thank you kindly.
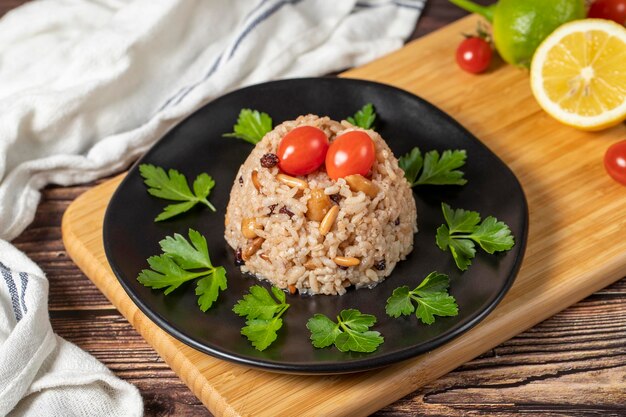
[225,115,417,295]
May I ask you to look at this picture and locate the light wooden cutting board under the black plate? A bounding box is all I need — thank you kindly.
[63,16,626,417]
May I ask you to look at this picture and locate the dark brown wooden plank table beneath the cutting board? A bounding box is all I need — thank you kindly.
[0,0,626,416]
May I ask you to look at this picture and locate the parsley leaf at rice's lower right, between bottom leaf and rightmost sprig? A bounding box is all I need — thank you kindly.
[385,272,459,324]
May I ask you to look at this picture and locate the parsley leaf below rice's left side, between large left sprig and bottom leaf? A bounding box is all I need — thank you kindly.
[233,285,289,351]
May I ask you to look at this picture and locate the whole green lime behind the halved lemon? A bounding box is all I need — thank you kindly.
[450,0,587,68]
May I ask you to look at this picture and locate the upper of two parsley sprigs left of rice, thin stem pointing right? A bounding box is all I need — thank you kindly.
[139,164,216,222]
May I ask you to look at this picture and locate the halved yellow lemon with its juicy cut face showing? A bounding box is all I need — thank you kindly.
[530,19,626,130]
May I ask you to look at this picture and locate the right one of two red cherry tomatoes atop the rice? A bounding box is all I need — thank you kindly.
[326,130,376,180]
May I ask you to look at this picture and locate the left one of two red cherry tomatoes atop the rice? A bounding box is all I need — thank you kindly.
[278,126,328,175]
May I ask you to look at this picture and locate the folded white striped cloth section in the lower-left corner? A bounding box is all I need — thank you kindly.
[0,240,143,417]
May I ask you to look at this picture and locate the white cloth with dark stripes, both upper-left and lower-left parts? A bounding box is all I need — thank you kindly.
[0,0,425,416]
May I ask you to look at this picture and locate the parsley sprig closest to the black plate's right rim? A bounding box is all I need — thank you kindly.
[436,203,515,271]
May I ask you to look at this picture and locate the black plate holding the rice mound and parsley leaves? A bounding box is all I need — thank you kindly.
[104,78,528,373]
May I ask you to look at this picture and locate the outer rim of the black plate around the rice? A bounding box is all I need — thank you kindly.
[102,76,529,375]
